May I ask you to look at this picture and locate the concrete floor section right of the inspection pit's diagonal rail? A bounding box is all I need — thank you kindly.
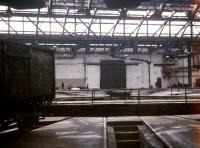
[142,116,200,148]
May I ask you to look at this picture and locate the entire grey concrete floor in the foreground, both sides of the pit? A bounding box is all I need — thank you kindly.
[0,115,200,148]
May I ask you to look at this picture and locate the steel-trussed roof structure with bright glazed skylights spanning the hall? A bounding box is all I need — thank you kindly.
[0,0,200,54]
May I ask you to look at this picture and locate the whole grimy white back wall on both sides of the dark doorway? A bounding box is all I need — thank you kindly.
[55,55,168,89]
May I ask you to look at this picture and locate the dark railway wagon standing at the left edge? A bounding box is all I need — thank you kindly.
[0,40,55,129]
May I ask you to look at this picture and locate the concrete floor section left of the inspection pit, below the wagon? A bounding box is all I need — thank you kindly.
[0,118,104,148]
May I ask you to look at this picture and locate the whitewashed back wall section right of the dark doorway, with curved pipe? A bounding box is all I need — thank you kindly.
[126,55,167,88]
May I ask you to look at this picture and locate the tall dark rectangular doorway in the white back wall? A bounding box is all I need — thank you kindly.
[100,60,126,89]
